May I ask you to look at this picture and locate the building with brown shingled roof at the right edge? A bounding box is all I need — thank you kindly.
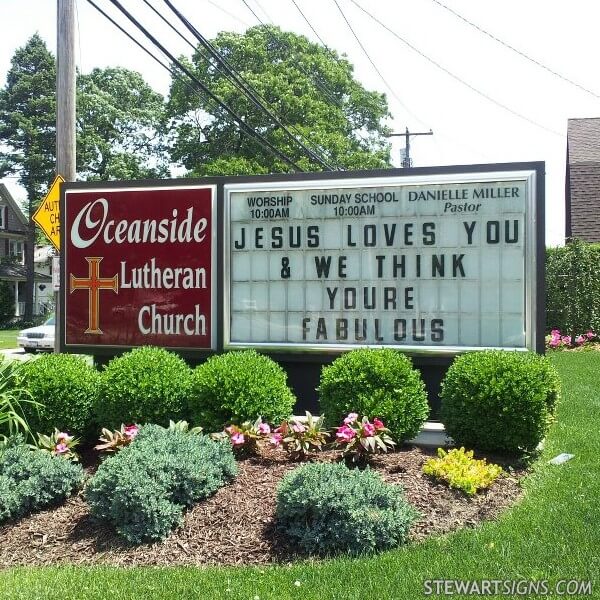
[565,118,600,242]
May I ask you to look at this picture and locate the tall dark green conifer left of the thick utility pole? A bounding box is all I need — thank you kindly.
[0,33,56,321]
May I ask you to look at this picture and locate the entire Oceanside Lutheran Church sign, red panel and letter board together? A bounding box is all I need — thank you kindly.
[61,163,544,362]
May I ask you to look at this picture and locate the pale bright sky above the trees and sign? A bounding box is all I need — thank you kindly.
[0,0,600,245]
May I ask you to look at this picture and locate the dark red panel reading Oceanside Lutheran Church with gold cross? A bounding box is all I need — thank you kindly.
[63,185,216,349]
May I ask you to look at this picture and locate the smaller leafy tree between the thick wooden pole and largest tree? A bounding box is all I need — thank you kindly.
[77,67,168,180]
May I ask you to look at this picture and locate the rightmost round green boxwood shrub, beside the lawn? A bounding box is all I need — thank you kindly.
[440,350,560,453]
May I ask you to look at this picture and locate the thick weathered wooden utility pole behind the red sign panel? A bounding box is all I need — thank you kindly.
[54,0,75,352]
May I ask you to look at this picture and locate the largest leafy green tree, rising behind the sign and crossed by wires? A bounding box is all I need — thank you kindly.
[167,26,390,176]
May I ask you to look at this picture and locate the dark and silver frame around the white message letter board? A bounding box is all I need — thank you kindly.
[222,162,545,360]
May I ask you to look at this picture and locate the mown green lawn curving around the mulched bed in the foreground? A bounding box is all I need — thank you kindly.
[0,352,600,600]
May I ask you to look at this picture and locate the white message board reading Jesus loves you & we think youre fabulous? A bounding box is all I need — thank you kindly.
[224,166,537,353]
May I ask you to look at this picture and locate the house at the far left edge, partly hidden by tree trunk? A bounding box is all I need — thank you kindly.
[0,183,52,317]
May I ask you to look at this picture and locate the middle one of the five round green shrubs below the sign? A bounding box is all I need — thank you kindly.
[190,350,296,431]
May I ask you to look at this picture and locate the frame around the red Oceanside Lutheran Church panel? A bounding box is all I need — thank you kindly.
[59,177,222,359]
